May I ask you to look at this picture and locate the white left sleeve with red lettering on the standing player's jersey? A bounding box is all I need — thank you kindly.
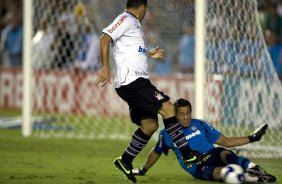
[103,15,131,41]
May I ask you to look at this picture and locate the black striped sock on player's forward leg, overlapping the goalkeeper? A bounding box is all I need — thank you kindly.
[164,116,191,160]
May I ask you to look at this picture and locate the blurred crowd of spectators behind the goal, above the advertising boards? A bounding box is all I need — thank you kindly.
[0,0,282,78]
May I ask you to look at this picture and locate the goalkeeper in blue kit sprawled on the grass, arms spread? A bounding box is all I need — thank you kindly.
[133,99,276,182]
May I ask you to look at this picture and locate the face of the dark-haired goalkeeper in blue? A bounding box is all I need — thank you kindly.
[176,106,191,128]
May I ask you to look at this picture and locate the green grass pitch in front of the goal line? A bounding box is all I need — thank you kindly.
[0,129,282,184]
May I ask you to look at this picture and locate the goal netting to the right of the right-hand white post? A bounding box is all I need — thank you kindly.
[205,0,282,157]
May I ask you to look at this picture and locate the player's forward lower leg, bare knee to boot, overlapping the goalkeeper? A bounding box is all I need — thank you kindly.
[158,100,210,165]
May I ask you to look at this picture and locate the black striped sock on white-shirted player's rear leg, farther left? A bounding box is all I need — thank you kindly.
[122,128,151,165]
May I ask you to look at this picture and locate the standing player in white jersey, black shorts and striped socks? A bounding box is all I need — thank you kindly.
[96,0,210,182]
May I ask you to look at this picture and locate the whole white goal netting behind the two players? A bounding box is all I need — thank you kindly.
[22,0,282,157]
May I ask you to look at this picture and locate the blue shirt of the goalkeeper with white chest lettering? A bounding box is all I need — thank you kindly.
[154,119,221,176]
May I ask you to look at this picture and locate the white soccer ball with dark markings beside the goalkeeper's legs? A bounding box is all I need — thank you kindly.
[220,164,245,183]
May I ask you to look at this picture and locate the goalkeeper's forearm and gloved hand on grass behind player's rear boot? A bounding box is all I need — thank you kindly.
[132,149,161,176]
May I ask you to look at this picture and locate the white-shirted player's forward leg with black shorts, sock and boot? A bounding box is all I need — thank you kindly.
[116,78,208,165]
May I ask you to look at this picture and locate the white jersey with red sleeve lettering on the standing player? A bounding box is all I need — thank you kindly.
[103,11,149,88]
